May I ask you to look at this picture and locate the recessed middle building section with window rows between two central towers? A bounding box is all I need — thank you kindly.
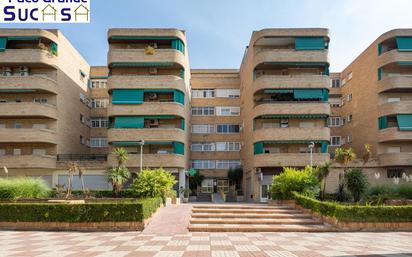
[190,69,242,194]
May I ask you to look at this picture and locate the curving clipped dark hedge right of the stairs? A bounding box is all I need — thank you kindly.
[293,192,412,222]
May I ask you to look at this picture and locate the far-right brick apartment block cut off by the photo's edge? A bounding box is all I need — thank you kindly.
[339,29,412,179]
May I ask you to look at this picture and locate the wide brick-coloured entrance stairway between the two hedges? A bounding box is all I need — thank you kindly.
[189,204,336,232]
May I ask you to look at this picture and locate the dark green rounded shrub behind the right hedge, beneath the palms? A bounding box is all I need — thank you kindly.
[345,169,368,202]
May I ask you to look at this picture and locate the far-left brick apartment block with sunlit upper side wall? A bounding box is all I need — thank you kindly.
[0,29,90,185]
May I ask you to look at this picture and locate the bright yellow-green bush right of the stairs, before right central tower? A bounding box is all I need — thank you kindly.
[271,167,320,200]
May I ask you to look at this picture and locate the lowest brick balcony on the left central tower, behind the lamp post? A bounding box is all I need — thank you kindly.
[108,154,186,168]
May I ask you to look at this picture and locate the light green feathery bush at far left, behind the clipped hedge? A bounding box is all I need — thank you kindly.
[0,177,51,200]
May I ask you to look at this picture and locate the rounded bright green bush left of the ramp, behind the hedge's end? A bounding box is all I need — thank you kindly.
[130,168,177,197]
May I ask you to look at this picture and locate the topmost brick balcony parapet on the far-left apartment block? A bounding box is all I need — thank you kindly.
[0,49,57,67]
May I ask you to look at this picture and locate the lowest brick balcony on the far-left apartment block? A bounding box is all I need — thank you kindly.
[0,155,56,169]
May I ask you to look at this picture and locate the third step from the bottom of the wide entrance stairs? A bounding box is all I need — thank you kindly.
[192,213,312,219]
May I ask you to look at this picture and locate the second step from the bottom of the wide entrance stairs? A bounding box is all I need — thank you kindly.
[190,218,322,225]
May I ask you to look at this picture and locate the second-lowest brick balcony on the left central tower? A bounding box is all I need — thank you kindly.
[107,128,186,142]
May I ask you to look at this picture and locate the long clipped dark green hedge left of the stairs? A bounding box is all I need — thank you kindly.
[0,198,162,222]
